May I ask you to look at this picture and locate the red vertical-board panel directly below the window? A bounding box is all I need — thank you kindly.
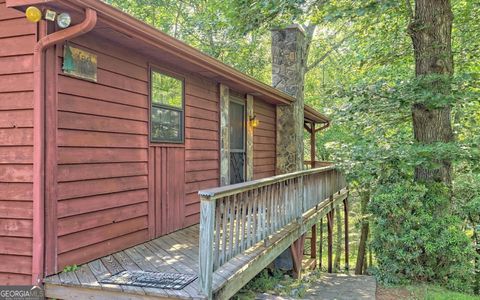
[149,145,185,237]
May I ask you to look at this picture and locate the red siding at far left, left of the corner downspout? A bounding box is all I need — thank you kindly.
[0,0,36,285]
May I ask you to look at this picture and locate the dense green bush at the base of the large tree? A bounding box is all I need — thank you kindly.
[369,181,475,292]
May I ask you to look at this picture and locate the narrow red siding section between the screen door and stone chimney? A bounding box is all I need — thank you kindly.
[253,99,276,179]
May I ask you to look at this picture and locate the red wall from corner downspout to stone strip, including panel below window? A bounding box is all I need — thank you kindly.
[55,35,219,270]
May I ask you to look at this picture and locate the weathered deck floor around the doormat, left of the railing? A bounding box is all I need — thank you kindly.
[45,225,207,299]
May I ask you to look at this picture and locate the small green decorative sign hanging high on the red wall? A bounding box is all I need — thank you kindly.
[62,43,97,82]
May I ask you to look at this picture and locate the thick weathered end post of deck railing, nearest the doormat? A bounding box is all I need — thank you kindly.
[199,196,216,299]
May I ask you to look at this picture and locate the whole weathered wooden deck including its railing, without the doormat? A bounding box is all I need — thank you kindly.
[45,167,348,299]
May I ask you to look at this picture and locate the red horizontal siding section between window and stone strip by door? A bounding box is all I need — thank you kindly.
[184,76,220,226]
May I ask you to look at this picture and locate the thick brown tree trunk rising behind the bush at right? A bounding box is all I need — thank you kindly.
[406,0,453,185]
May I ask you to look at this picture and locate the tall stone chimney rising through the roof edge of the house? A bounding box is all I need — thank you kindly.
[272,25,305,174]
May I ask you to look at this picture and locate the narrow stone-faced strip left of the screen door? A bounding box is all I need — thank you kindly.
[220,84,230,186]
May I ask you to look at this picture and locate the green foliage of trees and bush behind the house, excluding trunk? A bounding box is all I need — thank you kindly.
[105,0,480,289]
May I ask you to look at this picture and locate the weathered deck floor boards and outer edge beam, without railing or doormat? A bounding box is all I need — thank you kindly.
[45,192,348,300]
